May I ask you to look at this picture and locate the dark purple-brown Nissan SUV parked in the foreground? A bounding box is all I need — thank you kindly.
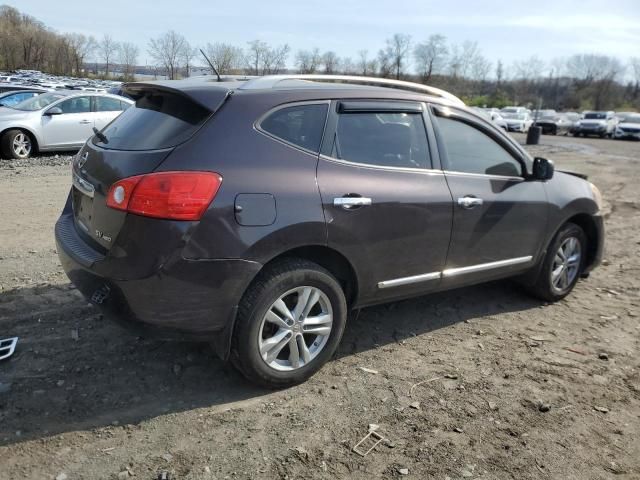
[55,75,604,387]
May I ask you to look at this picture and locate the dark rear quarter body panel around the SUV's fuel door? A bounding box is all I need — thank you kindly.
[158,95,326,264]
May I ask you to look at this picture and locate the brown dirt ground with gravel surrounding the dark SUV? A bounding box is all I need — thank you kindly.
[0,136,640,480]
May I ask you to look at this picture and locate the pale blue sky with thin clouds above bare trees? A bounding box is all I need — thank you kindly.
[12,0,640,73]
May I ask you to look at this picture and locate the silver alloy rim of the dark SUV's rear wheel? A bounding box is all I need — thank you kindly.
[258,286,333,371]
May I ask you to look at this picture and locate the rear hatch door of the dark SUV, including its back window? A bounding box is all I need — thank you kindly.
[72,84,227,253]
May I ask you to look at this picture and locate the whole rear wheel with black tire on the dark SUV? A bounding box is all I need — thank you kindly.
[231,258,347,388]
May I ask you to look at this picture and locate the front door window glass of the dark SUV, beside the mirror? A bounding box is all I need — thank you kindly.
[438,117,522,177]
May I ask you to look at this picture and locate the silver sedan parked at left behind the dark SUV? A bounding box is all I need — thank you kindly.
[0,91,134,158]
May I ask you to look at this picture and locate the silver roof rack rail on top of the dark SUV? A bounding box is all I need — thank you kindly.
[239,74,464,105]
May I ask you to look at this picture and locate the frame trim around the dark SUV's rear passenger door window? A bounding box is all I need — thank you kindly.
[320,99,442,173]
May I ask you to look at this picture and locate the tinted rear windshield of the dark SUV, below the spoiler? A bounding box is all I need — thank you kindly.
[93,90,211,150]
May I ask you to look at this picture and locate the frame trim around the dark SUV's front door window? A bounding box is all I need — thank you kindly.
[429,105,530,179]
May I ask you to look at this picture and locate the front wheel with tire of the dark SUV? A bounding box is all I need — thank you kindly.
[528,223,587,302]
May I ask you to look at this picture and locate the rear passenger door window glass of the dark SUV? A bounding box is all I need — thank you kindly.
[332,112,431,168]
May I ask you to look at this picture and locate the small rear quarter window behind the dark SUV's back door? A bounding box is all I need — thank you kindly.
[260,104,327,152]
